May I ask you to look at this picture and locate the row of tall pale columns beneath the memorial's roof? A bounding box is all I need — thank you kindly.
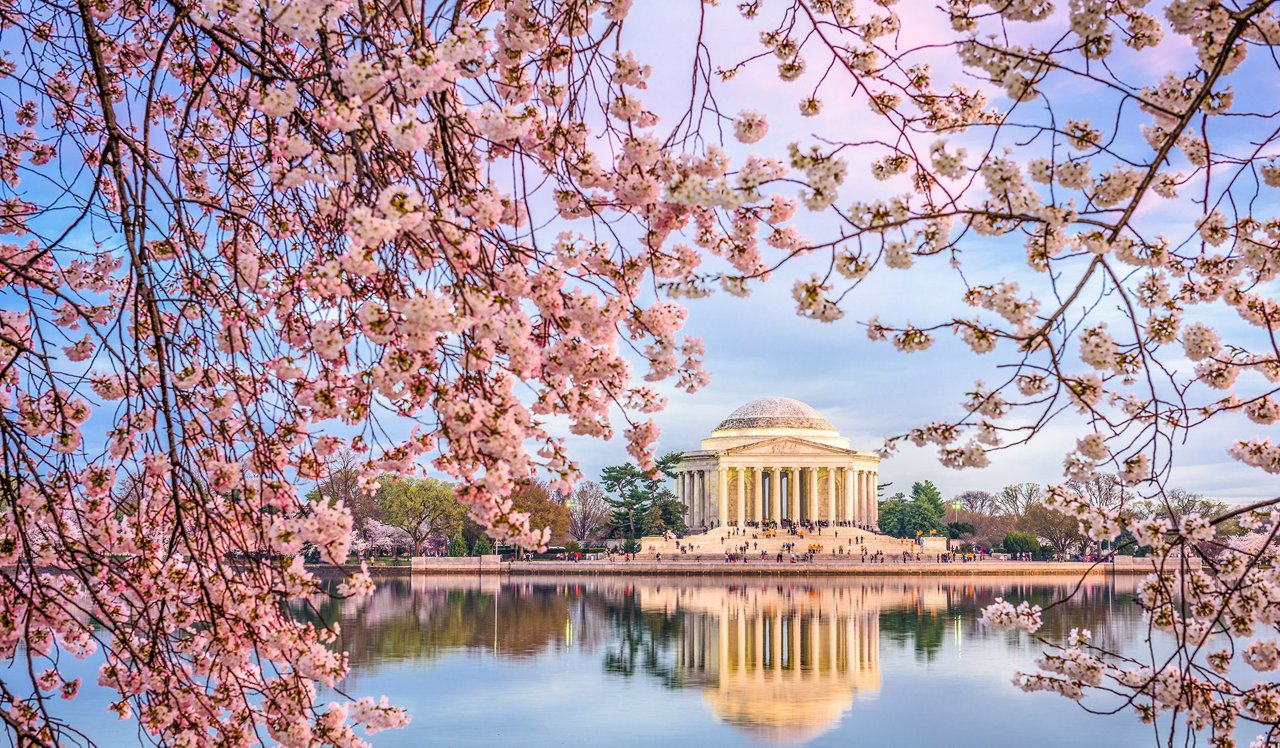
[676,464,879,530]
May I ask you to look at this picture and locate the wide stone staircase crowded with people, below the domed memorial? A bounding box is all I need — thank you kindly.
[636,528,946,560]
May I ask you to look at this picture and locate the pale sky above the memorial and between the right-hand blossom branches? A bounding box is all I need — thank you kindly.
[558,3,1280,502]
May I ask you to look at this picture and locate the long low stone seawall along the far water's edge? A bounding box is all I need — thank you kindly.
[399,557,1199,576]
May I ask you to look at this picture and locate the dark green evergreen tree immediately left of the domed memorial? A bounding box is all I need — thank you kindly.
[600,452,689,538]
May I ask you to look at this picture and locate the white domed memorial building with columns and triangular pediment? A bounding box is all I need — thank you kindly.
[676,397,879,533]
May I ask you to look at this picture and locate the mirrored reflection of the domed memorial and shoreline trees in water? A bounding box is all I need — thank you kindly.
[317,575,1143,743]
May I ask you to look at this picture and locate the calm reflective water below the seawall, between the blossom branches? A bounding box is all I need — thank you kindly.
[323,576,1153,748]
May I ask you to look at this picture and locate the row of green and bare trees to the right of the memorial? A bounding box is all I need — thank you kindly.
[879,474,1244,553]
